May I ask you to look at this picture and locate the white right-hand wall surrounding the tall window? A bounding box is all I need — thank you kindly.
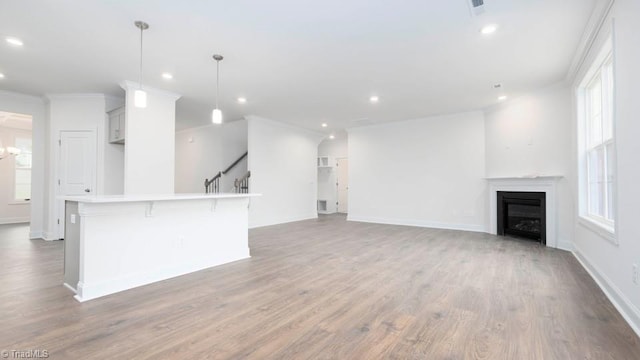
[573,0,640,334]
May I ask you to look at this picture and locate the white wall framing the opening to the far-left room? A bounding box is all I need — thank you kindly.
[0,91,48,239]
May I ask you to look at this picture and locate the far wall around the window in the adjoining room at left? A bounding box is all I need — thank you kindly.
[0,126,31,224]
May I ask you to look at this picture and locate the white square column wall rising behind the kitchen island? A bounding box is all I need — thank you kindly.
[122,82,180,195]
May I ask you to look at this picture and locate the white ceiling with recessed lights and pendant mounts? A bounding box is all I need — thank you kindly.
[0,0,597,132]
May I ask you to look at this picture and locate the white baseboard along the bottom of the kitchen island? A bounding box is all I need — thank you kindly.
[76,248,251,302]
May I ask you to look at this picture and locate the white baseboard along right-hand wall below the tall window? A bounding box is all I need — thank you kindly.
[573,244,640,337]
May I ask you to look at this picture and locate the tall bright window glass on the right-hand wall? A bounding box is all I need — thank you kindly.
[578,42,615,234]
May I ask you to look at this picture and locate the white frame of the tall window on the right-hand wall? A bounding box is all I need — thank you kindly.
[576,36,618,244]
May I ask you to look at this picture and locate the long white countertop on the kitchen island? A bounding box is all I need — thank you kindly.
[58,193,261,204]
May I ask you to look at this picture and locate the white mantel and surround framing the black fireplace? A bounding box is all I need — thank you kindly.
[485,176,562,248]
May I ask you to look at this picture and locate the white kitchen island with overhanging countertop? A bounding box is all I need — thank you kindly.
[62,194,257,301]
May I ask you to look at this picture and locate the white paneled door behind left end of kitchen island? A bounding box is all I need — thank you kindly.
[58,131,96,239]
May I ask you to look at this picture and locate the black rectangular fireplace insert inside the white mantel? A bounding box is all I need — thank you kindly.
[496,191,547,245]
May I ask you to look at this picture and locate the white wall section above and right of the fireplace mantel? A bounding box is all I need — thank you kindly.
[485,84,574,248]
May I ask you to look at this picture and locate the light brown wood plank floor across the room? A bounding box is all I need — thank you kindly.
[0,215,640,360]
